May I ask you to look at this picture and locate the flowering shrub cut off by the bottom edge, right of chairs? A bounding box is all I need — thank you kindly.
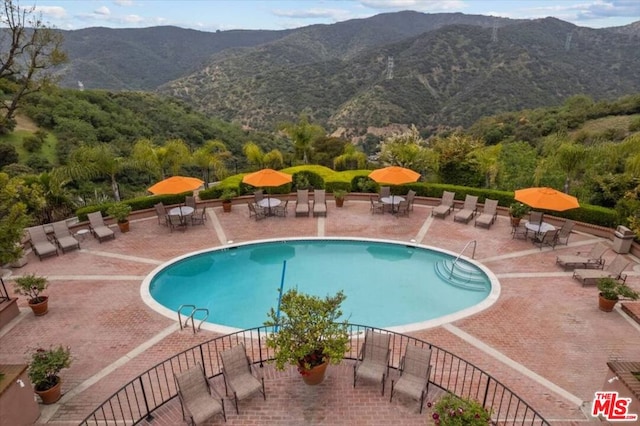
[427,394,491,426]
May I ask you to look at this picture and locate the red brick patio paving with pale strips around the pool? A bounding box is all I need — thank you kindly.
[0,201,640,425]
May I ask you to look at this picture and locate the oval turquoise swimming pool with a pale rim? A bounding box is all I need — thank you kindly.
[141,238,499,332]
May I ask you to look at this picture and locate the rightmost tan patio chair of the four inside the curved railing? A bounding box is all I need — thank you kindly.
[389,344,431,414]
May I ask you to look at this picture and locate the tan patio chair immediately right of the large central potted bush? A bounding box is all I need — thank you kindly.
[353,329,391,395]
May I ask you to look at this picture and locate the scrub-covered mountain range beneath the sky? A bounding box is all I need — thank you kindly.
[53,12,640,136]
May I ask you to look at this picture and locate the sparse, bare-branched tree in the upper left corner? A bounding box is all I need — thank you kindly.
[0,0,67,133]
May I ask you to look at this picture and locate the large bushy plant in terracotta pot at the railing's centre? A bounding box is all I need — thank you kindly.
[265,288,349,385]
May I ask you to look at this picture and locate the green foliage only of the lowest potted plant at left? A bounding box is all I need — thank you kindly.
[28,345,71,391]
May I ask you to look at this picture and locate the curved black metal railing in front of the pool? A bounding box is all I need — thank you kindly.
[80,324,549,426]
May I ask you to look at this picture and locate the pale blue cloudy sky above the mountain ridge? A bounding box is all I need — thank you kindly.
[31,0,640,31]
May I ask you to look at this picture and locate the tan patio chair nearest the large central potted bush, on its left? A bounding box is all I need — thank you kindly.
[220,343,267,414]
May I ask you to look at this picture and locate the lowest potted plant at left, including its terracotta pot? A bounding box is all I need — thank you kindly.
[27,346,71,404]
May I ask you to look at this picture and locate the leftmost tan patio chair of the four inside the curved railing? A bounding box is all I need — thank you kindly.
[174,363,227,425]
